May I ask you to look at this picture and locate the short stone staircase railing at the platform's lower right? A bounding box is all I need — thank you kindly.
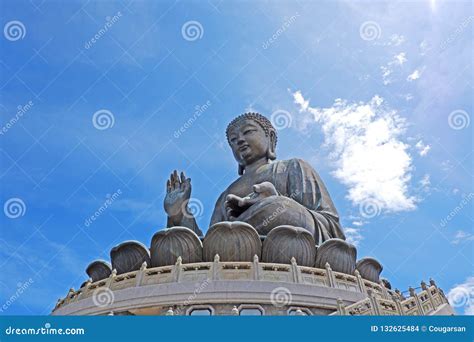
[332,280,449,316]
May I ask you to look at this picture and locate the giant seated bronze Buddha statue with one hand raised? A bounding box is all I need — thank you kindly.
[164,113,345,245]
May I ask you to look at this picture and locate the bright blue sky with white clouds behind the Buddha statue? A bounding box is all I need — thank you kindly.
[0,0,474,314]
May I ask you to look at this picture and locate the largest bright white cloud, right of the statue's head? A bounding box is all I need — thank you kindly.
[293,91,416,212]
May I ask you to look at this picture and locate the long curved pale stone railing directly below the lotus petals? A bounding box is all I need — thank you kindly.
[53,255,392,311]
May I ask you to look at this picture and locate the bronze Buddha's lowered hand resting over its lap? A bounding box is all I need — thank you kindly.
[225,182,278,220]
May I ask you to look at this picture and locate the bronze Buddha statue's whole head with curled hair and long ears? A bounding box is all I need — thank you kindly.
[226,113,277,175]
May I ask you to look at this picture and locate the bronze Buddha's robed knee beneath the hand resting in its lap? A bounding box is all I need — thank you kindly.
[238,196,315,236]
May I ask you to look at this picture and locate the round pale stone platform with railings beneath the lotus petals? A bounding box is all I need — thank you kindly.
[52,255,453,315]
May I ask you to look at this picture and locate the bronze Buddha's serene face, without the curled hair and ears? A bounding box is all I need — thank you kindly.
[229,119,270,166]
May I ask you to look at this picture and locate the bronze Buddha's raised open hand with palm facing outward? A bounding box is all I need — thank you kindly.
[164,170,191,217]
